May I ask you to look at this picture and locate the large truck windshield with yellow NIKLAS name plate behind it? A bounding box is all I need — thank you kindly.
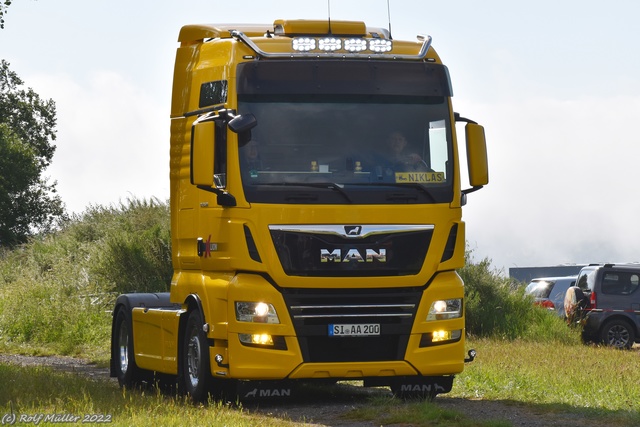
[238,62,453,203]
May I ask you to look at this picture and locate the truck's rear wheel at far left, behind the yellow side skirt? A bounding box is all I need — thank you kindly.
[111,307,142,388]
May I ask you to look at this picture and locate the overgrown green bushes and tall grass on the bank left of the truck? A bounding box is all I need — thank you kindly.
[0,199,173,354]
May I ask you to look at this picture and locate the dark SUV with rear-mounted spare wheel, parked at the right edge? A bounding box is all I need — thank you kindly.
[564,264,640,348]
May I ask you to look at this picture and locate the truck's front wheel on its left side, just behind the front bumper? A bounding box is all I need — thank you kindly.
[181,310,212,402]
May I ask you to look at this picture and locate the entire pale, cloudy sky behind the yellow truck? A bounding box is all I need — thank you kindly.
[0,0,640,275]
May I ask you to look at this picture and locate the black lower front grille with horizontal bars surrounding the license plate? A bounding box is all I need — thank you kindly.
[283,288,422,362]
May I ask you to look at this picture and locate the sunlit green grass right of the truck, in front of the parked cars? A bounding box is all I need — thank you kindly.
[450,339,640,426]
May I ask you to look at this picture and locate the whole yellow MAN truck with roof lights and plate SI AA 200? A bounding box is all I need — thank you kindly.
[111,20,488,400]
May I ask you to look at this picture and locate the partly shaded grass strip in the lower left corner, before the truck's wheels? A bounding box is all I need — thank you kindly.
[0,365,296,427]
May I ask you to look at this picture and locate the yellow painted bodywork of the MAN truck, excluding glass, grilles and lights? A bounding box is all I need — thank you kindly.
[133,20,478,379]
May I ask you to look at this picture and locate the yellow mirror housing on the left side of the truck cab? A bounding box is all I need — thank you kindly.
[191,121,215,187]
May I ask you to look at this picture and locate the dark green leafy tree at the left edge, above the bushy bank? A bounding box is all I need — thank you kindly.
[0,60,64,246]
